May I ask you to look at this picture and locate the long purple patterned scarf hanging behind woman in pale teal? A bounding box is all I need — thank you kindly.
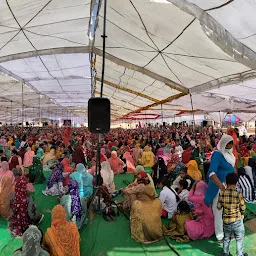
[68,180,82,220]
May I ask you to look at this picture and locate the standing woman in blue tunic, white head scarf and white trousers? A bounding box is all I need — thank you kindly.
[205,134,236,241]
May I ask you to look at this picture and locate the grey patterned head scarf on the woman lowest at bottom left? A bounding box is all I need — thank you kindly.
[22,225,42,256]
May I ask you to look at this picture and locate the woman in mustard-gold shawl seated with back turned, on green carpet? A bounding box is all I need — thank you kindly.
[130,183,163,243]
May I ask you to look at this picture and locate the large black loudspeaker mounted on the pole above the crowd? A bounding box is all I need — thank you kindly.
[88,98,110,133]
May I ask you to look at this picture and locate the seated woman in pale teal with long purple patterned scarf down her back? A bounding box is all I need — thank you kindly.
[60,180,87,230]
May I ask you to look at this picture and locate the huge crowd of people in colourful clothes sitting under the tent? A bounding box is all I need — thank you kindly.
[0,123,256,255]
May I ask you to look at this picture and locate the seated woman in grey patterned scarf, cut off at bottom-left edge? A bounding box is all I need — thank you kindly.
[13,225,50,256]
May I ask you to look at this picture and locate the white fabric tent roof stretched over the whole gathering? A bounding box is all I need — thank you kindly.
[0,0,256,121]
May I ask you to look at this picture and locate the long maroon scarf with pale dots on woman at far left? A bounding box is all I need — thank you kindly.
[10,176,29,236]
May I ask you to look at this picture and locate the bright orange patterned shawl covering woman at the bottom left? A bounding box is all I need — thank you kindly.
[51,205,80,255]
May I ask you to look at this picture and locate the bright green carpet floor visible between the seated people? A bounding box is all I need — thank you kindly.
[0,175,256,256]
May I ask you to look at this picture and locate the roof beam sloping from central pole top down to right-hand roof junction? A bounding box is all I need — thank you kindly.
[93,47,188,93]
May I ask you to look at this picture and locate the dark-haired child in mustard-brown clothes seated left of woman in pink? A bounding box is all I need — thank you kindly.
[165,201,192,242]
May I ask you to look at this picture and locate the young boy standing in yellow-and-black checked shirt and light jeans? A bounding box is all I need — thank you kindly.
[217,173,248,256]
